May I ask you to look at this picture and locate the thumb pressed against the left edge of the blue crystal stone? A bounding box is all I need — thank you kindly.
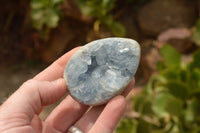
[0,79,66,121]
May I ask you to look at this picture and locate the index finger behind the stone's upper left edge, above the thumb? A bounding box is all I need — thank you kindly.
[34,47,80,81]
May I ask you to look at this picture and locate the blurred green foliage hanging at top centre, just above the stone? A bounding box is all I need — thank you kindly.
[75,0,125,36]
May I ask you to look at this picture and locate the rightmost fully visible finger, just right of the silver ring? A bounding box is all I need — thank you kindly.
[89,96,126,133]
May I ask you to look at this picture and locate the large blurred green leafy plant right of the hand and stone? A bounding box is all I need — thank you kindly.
[117,45,200,133]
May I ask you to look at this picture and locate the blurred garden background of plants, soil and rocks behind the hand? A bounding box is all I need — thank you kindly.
[0,0,200,133]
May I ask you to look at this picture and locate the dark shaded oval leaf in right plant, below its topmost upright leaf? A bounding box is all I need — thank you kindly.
[166,80,188,100]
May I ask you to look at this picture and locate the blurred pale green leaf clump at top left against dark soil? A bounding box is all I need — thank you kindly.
[31,0,63,34]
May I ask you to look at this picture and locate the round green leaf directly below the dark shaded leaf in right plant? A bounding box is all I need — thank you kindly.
[165,98,183,116]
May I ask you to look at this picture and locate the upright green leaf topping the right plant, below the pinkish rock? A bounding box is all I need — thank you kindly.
[160,44,181,67]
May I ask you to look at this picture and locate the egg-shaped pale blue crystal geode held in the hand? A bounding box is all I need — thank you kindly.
[64,38,140,105]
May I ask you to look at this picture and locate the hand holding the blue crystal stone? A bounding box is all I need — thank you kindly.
[0,48,134,133]
